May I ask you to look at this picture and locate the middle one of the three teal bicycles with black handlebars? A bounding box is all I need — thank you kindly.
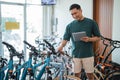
[19,41,41,80]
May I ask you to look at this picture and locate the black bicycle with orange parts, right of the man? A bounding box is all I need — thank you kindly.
[94,37,120,80]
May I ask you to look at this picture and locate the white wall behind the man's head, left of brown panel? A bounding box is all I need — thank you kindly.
[55,0,93,36]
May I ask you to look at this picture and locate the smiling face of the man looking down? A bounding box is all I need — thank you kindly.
[70,8,82,20]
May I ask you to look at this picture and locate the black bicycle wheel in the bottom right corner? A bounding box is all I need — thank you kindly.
[104,70,120,80]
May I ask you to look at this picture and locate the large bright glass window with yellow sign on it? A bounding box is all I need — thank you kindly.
[0,0,42,57]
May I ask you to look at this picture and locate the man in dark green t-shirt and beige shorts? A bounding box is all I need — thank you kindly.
[58,4,100,80]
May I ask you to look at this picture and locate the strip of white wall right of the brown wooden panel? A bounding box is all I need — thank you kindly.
[112,0,120,64]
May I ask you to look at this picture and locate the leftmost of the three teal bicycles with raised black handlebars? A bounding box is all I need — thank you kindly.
[2,42,21,80]
